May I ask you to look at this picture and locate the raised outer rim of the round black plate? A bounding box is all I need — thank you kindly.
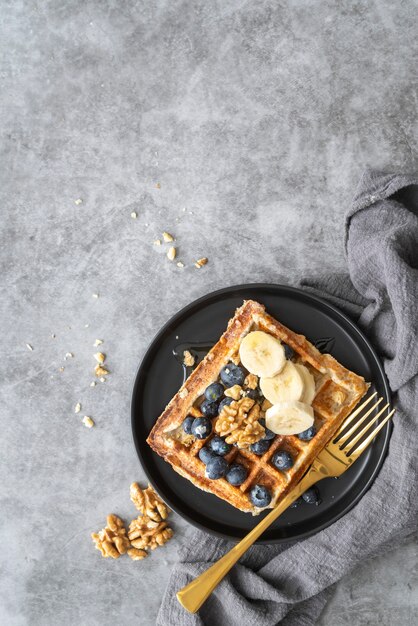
[130,283,392,544]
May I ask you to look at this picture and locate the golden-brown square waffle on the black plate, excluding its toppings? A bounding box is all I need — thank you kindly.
[147,300,369,515]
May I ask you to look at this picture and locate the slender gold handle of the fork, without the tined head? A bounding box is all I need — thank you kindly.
[177,466,325,613]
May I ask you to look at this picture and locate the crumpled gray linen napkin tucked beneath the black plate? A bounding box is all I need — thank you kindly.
[157,172,418,626]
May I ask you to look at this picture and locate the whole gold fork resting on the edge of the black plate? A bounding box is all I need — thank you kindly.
[177,392,395,613]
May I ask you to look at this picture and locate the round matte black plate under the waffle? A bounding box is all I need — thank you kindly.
[132,284,390,543]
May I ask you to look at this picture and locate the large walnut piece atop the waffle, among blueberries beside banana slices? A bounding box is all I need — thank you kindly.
[215,397,265,448]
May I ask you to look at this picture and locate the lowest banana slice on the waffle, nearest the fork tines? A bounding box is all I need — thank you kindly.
[266,401,314,435]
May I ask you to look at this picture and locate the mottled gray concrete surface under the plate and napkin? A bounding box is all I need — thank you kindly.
[0,0,418,626]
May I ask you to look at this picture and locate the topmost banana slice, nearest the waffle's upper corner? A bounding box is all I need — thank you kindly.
[239,330,286,378]
